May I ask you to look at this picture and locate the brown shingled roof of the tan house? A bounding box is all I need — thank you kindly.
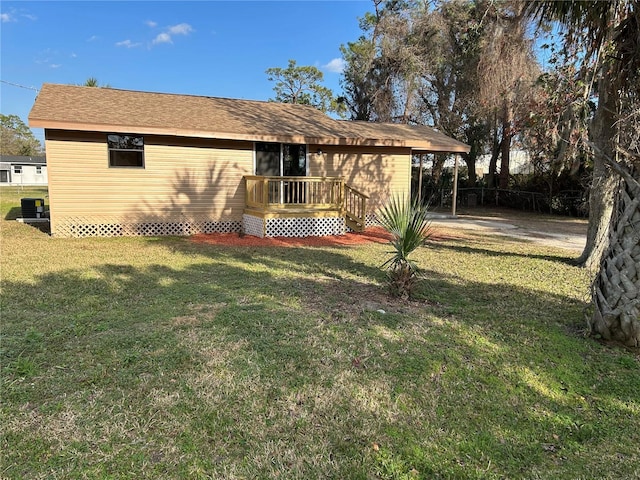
[29,84,469,152]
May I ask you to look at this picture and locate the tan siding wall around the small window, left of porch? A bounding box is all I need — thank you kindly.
[46,131,253,234]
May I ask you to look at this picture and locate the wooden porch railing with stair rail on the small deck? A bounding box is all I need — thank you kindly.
[244,175,369,231]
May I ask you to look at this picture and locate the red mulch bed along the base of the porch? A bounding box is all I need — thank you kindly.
[190,227,460,247]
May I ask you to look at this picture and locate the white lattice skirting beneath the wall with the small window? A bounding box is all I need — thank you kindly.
[52,217,242,237]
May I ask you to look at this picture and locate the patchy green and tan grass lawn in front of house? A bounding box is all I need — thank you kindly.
[0,188,640,479]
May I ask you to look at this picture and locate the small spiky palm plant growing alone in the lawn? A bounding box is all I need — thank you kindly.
[377,196,431,299]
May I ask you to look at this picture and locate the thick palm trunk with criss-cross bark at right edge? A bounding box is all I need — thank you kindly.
[590,163,640,347]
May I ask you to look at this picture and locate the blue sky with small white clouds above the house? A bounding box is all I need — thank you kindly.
[0,0,373,139]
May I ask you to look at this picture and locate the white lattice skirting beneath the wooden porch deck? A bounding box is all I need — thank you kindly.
[243,214,345,238]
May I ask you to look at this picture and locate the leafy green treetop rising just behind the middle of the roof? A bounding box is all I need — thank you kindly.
[266,60,344,114]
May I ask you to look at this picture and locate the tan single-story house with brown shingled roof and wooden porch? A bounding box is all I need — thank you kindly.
[29,84,469,237]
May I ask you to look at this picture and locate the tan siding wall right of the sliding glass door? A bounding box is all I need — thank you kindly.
[309,145,411,209]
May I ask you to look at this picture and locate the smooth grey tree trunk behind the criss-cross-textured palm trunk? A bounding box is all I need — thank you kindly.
[575,73,619,269]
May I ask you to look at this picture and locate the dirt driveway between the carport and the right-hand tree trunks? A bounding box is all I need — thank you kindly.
[432,208,588,252]
